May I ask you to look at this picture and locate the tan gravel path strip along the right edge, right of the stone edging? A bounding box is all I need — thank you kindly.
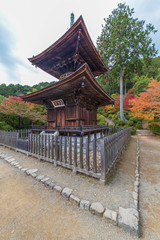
[139,136,160,240]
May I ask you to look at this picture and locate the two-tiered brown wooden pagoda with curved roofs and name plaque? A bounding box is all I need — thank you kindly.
[22,16,114,128]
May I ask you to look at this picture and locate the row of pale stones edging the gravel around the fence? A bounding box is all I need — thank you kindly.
[0,138,140,237]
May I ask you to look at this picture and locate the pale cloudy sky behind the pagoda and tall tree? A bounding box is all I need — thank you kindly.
[0,0,160,86]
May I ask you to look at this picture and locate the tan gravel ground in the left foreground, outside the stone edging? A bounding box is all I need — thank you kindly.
[0,158,137,240]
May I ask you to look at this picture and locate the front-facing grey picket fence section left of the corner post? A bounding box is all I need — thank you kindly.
[29,134,100,178]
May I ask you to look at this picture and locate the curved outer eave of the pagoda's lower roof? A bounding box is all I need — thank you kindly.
[22,63,114,105]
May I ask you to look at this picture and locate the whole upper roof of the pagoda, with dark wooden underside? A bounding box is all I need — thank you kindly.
[29,16,108,78]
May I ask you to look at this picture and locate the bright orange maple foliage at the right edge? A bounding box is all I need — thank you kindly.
[130,79,160,120]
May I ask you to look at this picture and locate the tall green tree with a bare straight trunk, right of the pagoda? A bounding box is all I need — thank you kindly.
[97,3,157,119]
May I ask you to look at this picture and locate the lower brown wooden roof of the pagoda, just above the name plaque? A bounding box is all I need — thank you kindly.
[22,63,114,106]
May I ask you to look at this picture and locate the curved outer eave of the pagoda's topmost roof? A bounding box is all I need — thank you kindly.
[28,16,108,75]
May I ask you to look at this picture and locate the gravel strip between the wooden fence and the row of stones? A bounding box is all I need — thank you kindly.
[0,138,136,211]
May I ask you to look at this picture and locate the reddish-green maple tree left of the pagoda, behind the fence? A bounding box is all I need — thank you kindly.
[0,96,47,122]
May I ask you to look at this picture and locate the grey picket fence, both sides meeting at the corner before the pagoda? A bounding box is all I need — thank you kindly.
[29,129,130,183]
